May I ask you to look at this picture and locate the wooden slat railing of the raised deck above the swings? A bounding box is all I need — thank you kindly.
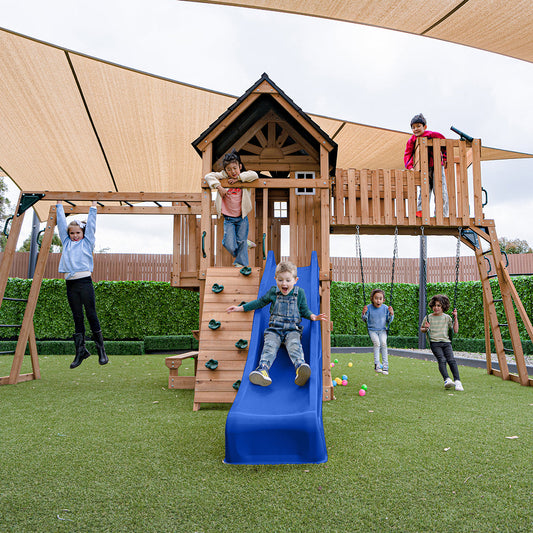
[331,137,484,229]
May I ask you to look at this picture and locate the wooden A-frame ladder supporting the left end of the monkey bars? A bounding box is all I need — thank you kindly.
[0,202,56,385]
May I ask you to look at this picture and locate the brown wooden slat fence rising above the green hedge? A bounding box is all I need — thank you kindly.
[4,252,533,283]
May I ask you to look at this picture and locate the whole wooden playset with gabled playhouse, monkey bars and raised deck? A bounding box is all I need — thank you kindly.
[0,74,533,400]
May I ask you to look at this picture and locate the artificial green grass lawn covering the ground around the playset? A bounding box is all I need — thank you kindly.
[0,354,533,533]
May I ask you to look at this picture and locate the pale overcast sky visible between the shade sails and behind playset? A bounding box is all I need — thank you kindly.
[0,0,533,257]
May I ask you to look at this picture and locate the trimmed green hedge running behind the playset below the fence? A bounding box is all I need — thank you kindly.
[0,276,533,353]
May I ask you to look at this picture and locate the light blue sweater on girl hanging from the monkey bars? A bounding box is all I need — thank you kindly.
[56,204,96,279]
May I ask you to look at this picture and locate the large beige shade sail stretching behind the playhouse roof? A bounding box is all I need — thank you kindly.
[0,30,531,220]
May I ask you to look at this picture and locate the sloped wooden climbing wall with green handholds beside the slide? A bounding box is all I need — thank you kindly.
[193,266,262,411]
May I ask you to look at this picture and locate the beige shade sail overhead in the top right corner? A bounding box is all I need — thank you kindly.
[189,0,533,62]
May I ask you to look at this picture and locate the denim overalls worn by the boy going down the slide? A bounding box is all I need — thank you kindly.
[259,287,305,368]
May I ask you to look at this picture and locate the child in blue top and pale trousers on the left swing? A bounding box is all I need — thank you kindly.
[361,289,394,376]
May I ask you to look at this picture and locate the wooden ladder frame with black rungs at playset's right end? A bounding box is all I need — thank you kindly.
[474,222,533,385]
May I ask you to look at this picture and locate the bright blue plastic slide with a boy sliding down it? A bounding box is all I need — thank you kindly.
[224,251,328,465]
